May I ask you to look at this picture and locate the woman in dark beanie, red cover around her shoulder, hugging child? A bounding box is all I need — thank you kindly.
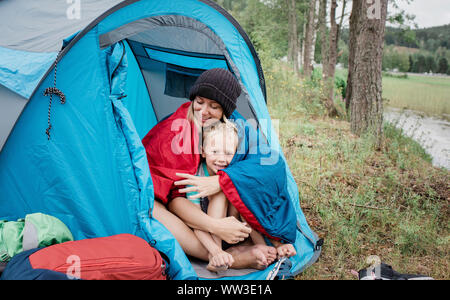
[142,69,296,269]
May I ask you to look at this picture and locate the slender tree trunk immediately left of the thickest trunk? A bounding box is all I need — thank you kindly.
[323,0,338,117]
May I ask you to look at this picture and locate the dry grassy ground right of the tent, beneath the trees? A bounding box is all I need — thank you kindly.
[265,59,450,279]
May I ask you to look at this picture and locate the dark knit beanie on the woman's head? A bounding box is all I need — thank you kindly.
[189,68,241,118]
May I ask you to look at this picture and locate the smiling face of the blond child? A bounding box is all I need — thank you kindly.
[202,134,237,175]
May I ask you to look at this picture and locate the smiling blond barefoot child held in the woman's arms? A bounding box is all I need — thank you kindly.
[186,120,296,272]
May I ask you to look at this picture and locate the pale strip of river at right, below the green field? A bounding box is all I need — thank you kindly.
[384,107,450,170]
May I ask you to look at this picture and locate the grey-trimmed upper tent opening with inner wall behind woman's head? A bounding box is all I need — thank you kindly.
[100,15,257,122]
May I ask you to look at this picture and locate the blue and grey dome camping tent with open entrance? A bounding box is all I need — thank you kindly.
[0,0,320,279]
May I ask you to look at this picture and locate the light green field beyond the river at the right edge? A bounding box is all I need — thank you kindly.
[383,75,450,116]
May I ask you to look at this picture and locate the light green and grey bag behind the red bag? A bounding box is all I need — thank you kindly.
[0,213,73,262]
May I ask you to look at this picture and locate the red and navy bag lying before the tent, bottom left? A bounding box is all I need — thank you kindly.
[1,234,167,280]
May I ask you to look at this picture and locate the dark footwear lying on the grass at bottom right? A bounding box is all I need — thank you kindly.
[356,262,433,280]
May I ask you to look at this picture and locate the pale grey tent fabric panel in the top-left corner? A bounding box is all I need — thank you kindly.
[0,0,123,52]
